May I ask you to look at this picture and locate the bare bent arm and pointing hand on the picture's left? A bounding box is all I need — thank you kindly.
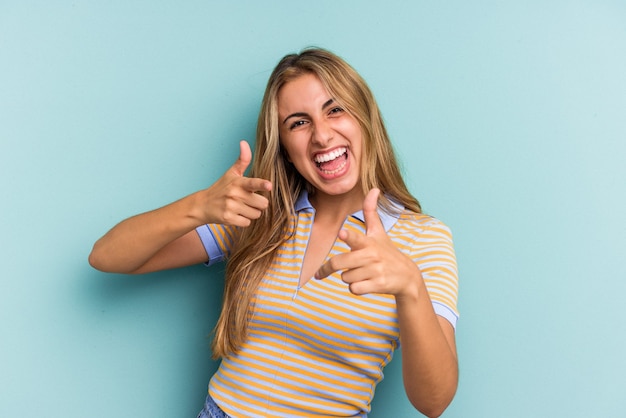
[89,141,272,274]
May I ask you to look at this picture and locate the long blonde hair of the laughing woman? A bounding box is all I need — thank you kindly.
[212,48,421,358]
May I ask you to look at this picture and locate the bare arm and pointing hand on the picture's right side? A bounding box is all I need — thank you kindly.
[315,189,458,417]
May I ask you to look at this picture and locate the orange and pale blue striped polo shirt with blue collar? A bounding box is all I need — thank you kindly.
[197,193,458,418]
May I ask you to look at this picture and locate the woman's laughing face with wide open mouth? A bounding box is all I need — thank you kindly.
[278,74,363,206]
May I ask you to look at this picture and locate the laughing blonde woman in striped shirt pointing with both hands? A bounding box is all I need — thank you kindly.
[90,49,458,417]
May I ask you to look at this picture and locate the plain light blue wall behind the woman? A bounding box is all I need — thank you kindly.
[0,0,626,418]
